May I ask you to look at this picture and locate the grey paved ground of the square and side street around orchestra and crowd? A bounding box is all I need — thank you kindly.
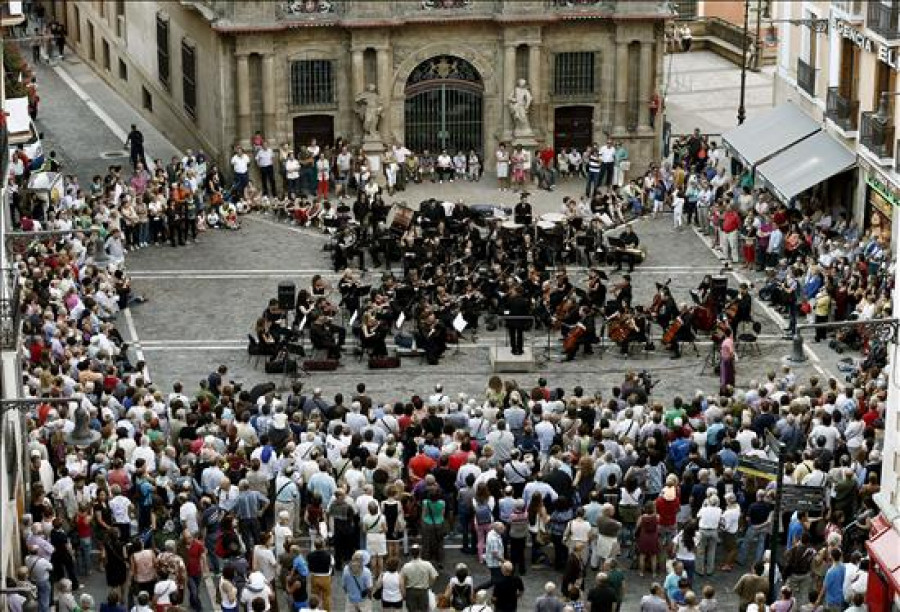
[38,45,852,610]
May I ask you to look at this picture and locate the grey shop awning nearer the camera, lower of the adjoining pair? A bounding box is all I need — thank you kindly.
[756,132,856,202]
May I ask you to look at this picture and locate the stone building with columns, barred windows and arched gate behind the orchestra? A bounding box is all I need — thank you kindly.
[40,0,671,170]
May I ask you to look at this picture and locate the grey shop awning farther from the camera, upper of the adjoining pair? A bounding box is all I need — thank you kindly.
[722,102,822,166]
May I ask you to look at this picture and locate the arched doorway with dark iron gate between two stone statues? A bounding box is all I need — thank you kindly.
[404,55,484,154]
